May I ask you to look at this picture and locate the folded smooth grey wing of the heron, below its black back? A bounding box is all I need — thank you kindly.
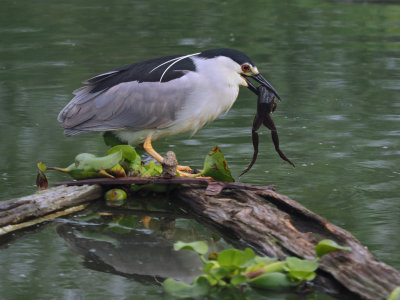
[58,72,196,135]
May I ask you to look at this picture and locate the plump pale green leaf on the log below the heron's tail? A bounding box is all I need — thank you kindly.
[75,151,122,171]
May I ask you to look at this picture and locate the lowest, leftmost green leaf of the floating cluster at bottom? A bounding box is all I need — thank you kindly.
[163,276,210,298]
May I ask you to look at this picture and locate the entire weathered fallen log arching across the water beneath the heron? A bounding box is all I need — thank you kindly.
[0,177,400,300]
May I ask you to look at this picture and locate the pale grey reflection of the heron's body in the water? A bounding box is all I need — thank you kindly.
[57,215,205,283]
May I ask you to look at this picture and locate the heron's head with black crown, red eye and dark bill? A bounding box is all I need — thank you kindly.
[199,48,281,99]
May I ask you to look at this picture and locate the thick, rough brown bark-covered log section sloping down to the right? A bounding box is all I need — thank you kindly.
[175,188,400,300]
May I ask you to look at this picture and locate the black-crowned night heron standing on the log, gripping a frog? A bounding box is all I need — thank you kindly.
[58,49,280,171]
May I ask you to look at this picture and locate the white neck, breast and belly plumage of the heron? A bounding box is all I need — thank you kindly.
[115,57,246,145]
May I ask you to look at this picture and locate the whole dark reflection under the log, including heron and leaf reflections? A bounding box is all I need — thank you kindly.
[57,197,227,284]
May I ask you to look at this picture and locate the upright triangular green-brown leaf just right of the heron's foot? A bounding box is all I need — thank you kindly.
[200,146,235,182]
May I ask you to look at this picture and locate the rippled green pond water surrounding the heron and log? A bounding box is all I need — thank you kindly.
[0,0,400,299]
